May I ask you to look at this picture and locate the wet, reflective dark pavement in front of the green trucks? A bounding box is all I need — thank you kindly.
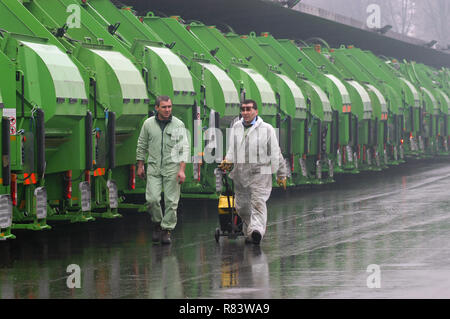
[0,161,450,298]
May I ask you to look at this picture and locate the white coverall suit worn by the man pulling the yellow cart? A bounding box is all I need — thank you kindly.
[225,117,287,239]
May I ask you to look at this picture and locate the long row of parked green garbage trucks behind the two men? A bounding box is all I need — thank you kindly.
[0,0,450,239]
